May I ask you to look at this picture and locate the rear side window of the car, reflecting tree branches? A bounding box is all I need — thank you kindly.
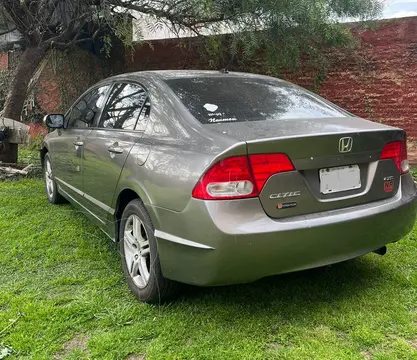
[99,84,147,130]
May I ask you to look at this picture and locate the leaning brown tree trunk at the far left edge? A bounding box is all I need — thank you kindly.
[0,47,47,163]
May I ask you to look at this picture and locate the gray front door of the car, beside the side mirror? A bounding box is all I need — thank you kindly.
[51,85,110,204]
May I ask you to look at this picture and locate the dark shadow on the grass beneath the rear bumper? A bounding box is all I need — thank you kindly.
[163,255,392,321]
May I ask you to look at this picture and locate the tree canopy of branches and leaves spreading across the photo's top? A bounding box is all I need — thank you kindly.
[0,0,382,67]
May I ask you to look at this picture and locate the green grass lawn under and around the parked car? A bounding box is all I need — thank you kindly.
[0,180,417,360]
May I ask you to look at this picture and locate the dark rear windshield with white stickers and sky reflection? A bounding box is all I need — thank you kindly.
[166,75,346,124]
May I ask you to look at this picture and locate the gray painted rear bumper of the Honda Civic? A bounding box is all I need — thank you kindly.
[154,175,417,286]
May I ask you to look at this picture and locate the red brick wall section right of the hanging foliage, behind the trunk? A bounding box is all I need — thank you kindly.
[319,17,417,162]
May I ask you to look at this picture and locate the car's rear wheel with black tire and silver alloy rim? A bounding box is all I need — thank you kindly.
[119,199,179,303]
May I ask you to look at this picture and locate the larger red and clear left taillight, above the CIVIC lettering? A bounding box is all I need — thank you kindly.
[192,154,294,200]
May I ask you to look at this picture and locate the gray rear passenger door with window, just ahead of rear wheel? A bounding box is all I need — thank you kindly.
[83,82,148,223]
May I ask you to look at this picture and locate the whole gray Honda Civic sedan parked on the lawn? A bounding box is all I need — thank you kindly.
[41,71,417,302]
